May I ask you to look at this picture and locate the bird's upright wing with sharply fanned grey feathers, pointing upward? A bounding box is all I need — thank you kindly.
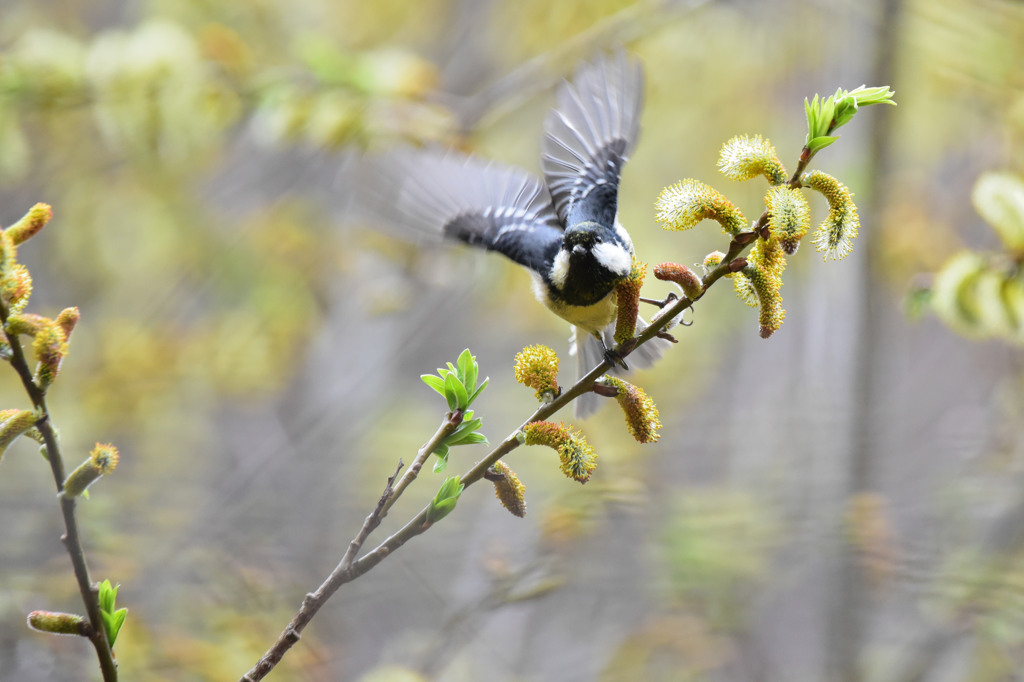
[543,51,643,226]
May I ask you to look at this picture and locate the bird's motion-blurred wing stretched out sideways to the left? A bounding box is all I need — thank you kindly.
[357,148,562,272]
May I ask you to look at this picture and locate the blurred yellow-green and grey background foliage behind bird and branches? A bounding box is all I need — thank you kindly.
[0,0,1024,682]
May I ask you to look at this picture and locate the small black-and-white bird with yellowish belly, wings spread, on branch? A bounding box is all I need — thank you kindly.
[357,49,669,418]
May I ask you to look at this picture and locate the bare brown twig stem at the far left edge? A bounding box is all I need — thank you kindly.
[0,302,118,682]
